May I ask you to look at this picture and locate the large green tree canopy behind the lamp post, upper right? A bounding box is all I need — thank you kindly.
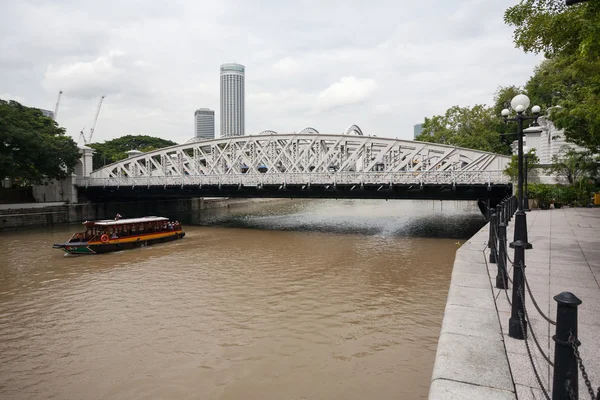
[419,0,600,154]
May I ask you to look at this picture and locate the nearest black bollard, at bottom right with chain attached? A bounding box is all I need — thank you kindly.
[552,292,582,400]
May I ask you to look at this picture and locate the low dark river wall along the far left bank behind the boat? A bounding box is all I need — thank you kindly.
[0,197,280,232]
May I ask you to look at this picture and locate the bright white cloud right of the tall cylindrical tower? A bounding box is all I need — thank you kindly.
[315,76,377,111]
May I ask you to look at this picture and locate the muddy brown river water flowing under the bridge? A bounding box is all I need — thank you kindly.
[0,200,484,399]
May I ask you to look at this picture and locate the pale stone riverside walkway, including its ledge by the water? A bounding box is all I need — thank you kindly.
[429,208,600,400]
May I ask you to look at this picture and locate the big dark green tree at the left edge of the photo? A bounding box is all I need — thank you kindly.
[0,99,80,186]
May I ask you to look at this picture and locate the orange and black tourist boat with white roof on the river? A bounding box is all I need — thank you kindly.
[52,215,185,254]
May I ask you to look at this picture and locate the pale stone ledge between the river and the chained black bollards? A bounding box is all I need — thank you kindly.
[429,224,516,400]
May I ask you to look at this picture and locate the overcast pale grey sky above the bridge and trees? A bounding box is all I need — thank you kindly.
[0,0,540,143]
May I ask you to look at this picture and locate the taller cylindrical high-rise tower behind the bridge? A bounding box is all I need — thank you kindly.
[221,64,246,137]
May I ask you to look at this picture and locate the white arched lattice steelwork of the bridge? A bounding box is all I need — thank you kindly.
[78,132,510,186]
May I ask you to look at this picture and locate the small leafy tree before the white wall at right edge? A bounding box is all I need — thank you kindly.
[547,146,600,185]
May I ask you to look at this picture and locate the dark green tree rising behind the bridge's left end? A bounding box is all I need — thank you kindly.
[89,135,177,169]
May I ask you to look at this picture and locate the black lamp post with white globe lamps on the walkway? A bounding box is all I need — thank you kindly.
[502,94,540,339]
